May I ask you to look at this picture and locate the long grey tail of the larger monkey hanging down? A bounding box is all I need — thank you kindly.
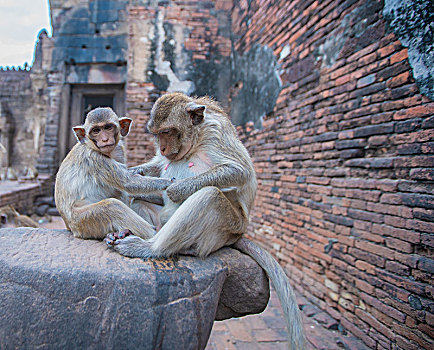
[233,238,305,350]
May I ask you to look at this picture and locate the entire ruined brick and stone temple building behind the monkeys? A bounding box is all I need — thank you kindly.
[0,0,434,349]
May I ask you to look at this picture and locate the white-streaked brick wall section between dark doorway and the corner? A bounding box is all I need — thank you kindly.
[126,0,232,165]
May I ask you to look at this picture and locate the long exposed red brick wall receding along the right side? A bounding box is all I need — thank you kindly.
[232,0,434,349]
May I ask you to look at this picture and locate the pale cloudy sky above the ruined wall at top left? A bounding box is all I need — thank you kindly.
[0,0,51,67]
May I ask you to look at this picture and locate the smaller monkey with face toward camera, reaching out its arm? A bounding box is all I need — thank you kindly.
[55,108,171,239]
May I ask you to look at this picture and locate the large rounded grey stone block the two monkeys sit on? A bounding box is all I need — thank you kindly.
[0,228,269,349]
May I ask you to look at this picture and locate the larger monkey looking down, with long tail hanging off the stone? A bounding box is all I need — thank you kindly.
[106,93,304,349]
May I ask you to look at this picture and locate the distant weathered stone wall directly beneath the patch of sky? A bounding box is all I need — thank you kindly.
[0,30,49,176]
